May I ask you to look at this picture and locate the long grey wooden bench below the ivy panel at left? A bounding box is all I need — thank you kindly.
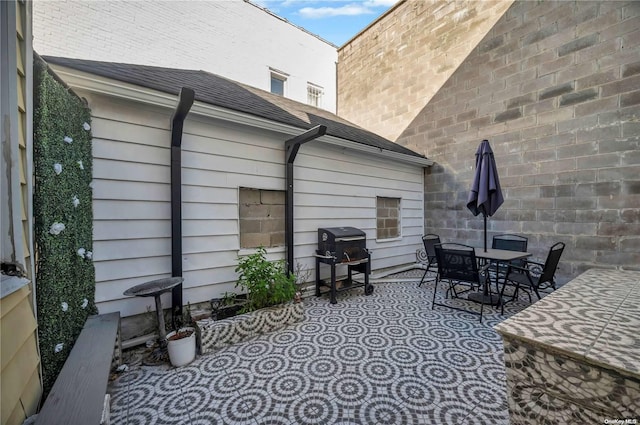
[35,312,122,425]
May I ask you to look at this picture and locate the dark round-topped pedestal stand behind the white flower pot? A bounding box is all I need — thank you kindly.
[123,276,184,365]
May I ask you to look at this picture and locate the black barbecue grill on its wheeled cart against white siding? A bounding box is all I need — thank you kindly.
[315,227,373,304]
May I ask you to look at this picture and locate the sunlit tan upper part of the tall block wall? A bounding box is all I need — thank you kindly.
[338,0,513,140]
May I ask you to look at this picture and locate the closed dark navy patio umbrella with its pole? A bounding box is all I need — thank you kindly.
[467,140,504,252]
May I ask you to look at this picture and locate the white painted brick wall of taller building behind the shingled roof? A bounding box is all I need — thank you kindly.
[33,0,338,112]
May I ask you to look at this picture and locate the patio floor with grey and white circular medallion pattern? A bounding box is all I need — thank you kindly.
[109,270,528,425]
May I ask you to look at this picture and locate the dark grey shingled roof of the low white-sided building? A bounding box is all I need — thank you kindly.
[43,56,424,158]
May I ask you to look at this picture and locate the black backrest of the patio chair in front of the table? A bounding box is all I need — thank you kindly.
[434,243,480,285]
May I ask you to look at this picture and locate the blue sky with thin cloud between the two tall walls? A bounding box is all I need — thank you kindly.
[251,0,397,47]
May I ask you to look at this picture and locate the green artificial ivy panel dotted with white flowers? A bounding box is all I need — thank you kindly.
[33,56,97,394]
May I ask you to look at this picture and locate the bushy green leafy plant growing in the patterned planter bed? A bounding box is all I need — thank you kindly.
[236,247,296,313]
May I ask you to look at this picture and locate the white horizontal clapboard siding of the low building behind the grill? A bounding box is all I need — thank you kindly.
[77,90,423,316]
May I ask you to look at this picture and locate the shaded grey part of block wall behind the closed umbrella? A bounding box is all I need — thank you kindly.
[398,1,640,280]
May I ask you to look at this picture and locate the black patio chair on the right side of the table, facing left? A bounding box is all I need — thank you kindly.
[501,242,565,308]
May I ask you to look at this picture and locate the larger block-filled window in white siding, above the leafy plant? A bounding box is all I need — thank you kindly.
[239,187,285,248]
